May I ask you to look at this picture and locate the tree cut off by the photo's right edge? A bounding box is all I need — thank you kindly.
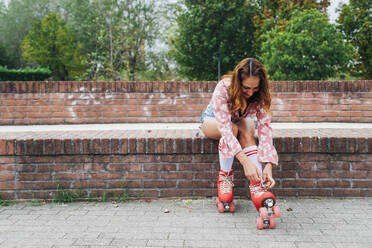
[337,0,372,79]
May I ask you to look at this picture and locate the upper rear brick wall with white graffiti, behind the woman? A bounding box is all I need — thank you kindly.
[0,80,372,125]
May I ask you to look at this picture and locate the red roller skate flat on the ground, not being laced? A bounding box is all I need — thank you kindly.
[216,170,235,213]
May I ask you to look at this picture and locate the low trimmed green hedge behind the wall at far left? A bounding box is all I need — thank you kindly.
[0,66,52,81]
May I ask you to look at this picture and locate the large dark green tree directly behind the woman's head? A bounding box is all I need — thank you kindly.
[171,0,256,80]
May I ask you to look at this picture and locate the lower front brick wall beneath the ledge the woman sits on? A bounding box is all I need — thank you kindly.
[0,129,372,200]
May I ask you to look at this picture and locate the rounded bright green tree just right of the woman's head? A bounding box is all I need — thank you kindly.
[261,9,351,80]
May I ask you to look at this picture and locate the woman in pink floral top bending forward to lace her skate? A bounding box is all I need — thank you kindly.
[200,58,278,207]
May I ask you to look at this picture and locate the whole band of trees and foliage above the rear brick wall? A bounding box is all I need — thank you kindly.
[0,0,372,81]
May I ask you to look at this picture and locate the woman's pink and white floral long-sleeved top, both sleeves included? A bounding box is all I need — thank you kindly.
[211,78,278,165]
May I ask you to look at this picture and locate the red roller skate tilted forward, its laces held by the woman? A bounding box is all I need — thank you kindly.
[249,182,280,229]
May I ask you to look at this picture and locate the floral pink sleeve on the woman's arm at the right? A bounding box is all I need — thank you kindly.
[257,105,278,165]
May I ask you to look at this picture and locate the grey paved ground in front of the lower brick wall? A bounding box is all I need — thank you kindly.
[0,198,372,248]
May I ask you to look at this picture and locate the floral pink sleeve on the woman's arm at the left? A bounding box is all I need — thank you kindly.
[212,81,242,159]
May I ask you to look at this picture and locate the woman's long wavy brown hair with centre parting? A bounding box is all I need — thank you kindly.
[222,58,271,114]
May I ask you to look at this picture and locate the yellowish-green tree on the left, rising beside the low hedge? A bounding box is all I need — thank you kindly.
[21,12,82,80]
